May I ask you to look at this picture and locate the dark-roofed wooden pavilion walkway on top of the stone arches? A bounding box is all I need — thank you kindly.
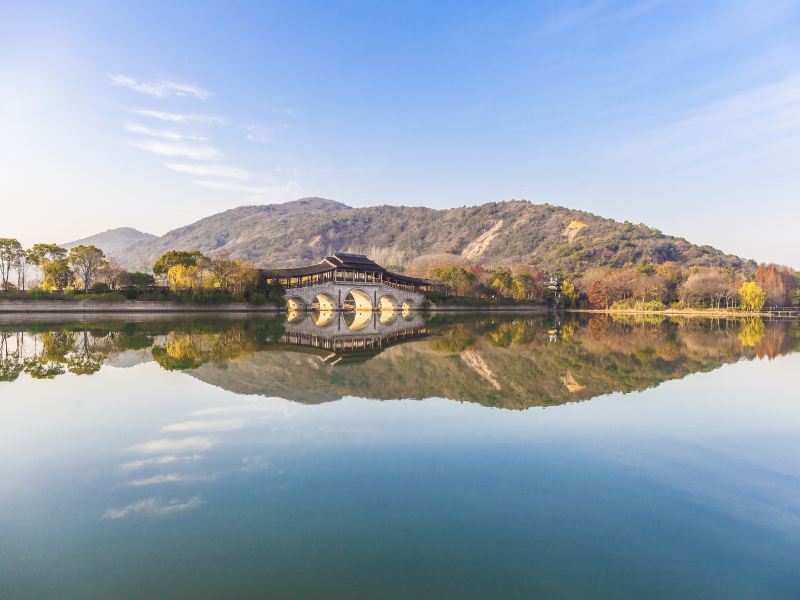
[261,252,435,294]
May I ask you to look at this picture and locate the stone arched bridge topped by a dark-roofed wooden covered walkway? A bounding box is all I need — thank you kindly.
[263,252,433,312]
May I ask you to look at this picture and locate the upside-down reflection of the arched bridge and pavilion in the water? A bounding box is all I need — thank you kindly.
[281,310,431,365]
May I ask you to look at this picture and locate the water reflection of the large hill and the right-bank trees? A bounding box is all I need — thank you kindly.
[191,317,798,408]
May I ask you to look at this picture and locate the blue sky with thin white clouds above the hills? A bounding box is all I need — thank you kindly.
[0,0,800,268]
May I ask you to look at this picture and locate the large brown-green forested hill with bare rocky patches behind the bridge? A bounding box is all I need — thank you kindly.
[115,198,755,272]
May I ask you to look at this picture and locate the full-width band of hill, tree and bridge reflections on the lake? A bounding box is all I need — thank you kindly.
[0,314,800,408]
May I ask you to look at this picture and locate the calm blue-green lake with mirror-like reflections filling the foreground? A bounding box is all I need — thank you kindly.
[0,313,800,599]
